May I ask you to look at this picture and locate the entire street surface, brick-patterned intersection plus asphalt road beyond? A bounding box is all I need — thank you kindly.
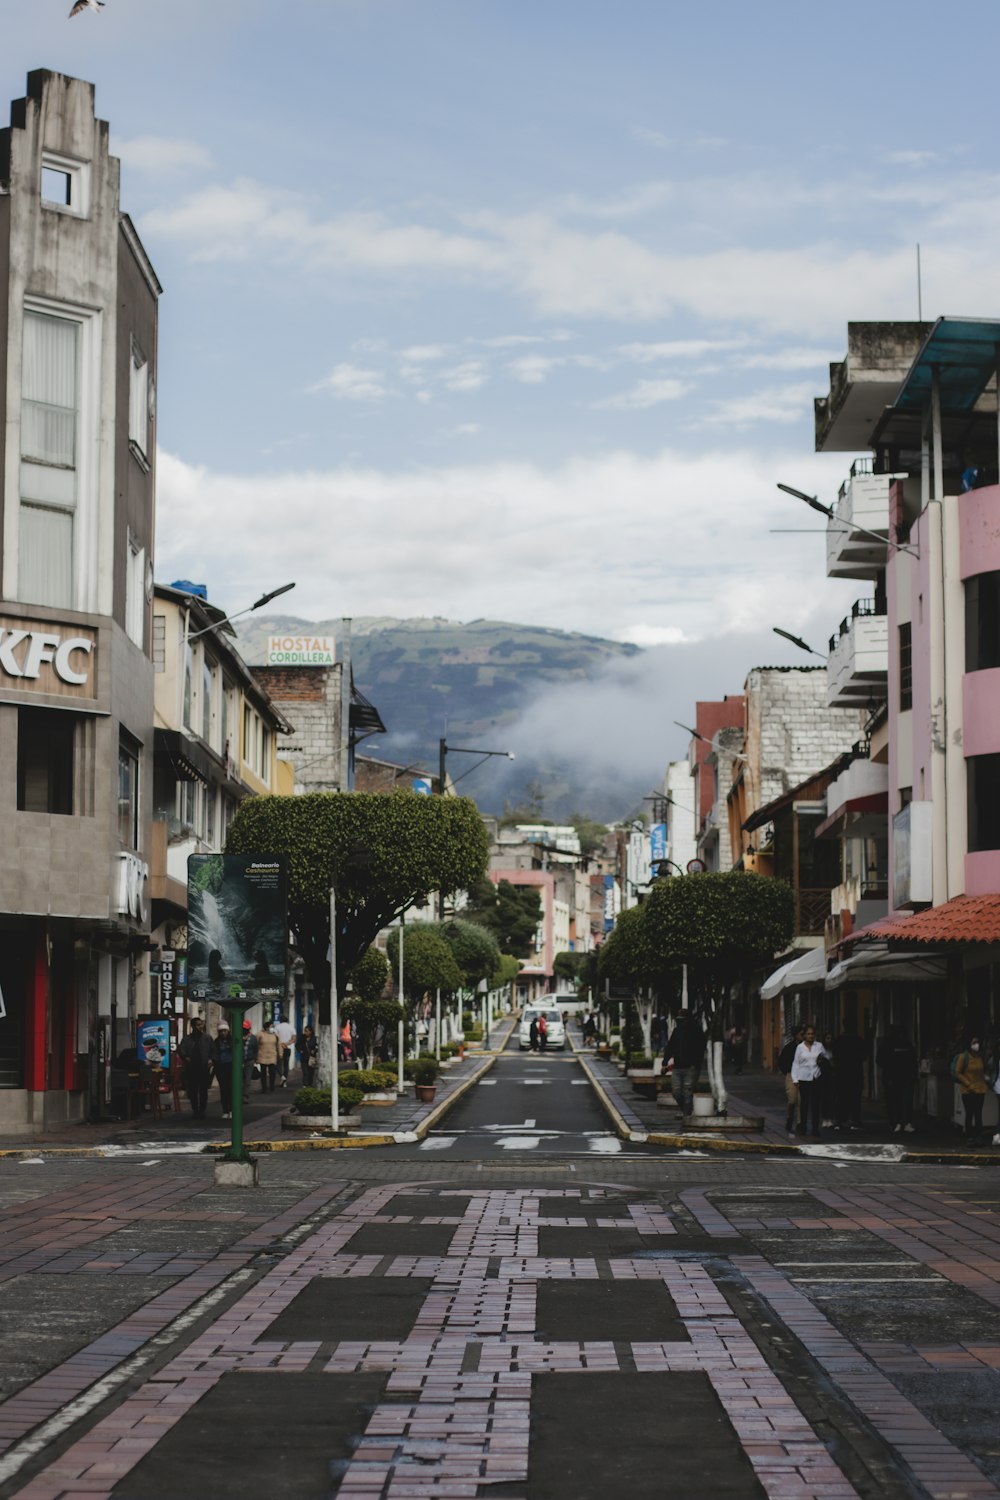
[0,1050,1000,1500]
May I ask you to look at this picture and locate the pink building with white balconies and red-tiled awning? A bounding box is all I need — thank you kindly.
[816,318,1000,1094]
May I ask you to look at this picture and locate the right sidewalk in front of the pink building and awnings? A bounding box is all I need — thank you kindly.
[574,1038,1000,1164]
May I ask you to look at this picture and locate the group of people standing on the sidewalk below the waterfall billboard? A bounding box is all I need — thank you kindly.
[177,1016,316,1121]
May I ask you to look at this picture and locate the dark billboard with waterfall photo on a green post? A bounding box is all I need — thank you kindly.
[187,854,288,1005]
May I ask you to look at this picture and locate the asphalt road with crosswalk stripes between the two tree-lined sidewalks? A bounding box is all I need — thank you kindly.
[390,1031,645,1161]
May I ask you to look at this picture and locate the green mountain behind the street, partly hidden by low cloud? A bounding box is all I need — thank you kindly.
[238,615,640,818]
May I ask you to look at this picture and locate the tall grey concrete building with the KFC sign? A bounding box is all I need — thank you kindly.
[0,71,160,1133]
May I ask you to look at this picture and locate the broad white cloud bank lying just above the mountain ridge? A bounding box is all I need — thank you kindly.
[157,440,858,642]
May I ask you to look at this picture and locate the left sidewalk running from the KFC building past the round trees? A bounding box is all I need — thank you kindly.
[0,1017,516,1157]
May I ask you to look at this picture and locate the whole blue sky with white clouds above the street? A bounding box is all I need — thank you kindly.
[0,0,1000,786]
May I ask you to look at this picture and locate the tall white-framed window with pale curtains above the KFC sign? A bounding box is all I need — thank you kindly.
[18,312,79,608]
